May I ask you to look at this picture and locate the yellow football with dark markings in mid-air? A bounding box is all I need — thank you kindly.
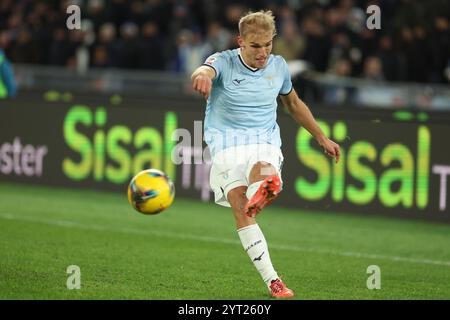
[127,169,175,215]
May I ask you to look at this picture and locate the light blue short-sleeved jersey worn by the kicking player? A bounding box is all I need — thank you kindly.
[204,49,292,156]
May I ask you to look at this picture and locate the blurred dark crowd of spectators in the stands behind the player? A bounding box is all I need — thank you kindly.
[0,0,450,83]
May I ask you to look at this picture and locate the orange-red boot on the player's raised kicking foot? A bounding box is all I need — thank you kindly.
[244,176,281,217]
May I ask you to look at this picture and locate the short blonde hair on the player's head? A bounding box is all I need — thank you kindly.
[239,10,277,37]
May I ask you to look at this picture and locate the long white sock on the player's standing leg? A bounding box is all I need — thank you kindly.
[238,224,278,287]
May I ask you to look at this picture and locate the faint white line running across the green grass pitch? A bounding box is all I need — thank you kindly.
[0,213,450,267]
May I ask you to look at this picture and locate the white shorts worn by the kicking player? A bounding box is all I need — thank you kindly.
[209,144,284,207]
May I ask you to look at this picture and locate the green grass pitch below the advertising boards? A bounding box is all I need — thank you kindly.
[0,183,450,300]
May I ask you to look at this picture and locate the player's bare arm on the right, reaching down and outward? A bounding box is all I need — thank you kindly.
[280,89,340,163]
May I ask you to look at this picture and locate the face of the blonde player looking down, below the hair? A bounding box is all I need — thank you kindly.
[239,31,273,69]
